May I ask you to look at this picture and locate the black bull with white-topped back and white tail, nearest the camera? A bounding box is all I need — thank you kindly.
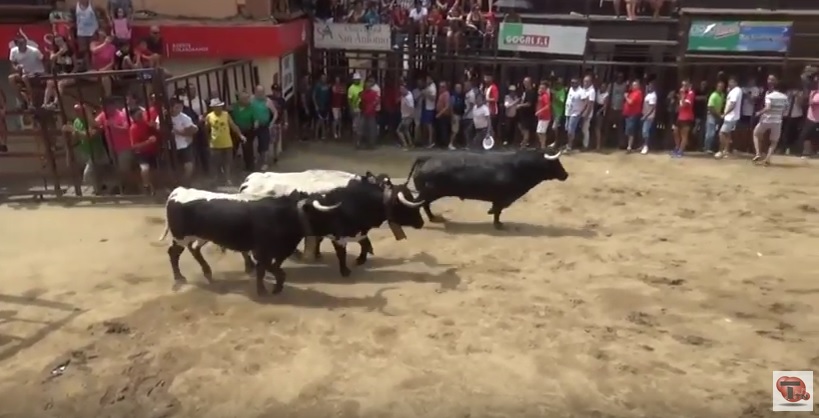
[159,187,341,295]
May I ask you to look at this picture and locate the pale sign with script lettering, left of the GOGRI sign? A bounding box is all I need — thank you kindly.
[313,21,392,51]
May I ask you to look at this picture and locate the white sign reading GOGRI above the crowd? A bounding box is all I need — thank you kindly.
[498,23,589,55]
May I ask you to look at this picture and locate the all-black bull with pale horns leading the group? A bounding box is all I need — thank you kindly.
[407,150,569,229]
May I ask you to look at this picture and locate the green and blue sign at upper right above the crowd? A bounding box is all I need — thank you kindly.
[688,20,793,53]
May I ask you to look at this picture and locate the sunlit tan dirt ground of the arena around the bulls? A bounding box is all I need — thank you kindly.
[0,147,819,418]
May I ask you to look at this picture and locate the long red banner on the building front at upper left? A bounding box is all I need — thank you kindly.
[0,19,309,59]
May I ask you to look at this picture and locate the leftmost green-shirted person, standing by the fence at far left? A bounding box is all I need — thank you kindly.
[63,104,107,195]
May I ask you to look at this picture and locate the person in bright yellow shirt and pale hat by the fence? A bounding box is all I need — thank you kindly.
[205,98,247,186]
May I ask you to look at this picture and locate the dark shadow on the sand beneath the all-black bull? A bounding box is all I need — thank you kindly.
[442,220,597,238]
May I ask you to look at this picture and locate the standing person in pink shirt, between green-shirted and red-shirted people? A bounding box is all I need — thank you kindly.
[94,97,134,184]
